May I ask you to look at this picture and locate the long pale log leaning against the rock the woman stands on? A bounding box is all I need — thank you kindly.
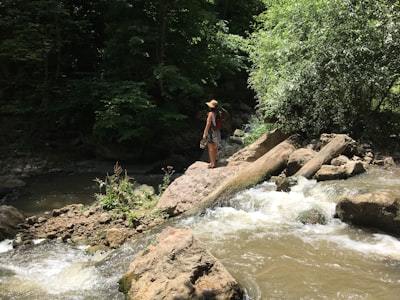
[184,137,297,215]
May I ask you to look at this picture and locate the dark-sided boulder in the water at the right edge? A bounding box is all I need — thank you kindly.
[336,192,400,236]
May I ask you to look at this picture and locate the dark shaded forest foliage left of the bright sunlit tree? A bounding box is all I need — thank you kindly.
[0,0,262,157]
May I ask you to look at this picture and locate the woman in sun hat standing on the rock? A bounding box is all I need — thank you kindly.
[203,99,221,169]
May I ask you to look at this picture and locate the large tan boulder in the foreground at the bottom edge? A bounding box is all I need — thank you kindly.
[119,227,244,300]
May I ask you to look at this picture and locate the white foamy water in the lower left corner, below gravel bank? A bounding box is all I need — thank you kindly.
[0,243,125,299]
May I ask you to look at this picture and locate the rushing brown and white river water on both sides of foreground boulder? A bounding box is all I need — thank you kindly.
[0,170,400,299]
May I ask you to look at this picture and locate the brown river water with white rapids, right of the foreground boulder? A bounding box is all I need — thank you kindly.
[179,173,400,299]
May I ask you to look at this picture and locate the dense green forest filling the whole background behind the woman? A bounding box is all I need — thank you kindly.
[0,0,400,161]
